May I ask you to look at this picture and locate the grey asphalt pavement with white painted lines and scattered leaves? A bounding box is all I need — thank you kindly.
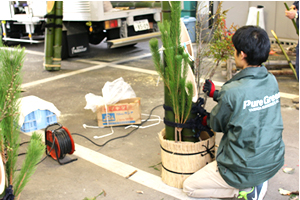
[3,39,299,200]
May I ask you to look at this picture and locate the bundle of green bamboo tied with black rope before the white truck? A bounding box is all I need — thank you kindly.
[44,1,63,71]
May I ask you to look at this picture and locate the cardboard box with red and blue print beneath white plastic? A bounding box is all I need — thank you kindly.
[97,97,141,126]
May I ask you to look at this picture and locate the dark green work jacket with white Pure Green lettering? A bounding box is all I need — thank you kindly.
[207,66,285,189]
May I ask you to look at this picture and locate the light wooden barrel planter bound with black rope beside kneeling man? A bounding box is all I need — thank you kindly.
[158,129,215,188]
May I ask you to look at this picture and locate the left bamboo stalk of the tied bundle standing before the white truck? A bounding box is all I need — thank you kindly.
[44,1,55,71]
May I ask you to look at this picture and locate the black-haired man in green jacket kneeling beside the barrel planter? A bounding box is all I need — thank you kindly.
[183,26,285,200]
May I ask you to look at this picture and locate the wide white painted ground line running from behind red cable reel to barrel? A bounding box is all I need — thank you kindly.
[23,130,192,200]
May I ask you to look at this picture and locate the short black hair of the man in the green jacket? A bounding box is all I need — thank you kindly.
[232,26,270,65]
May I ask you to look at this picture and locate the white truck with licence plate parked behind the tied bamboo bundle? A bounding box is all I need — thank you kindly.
[0,0,161,57]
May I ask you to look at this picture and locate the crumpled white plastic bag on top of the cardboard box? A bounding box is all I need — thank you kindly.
[84,77,136,112]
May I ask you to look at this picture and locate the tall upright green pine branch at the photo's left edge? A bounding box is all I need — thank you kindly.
[0,49,24,184]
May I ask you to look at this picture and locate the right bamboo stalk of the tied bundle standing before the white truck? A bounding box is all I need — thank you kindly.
[52,1,63,70]
